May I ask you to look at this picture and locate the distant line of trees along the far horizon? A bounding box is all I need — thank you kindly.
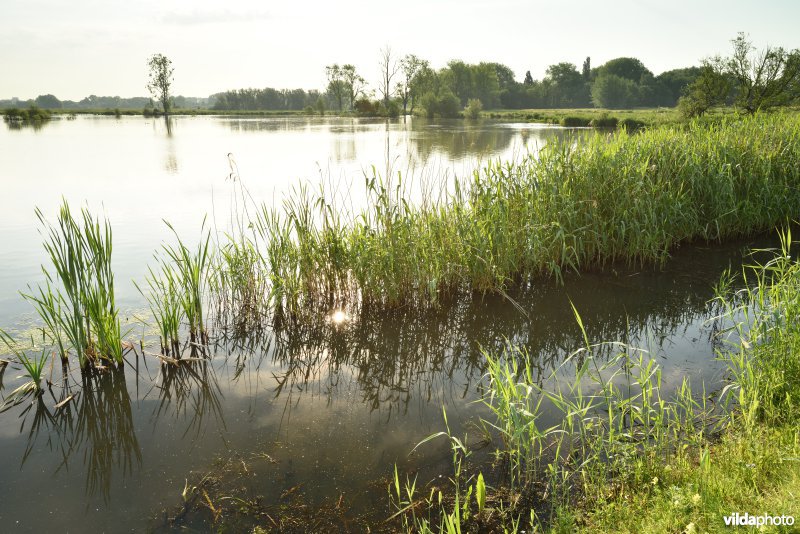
[9,34,800,117]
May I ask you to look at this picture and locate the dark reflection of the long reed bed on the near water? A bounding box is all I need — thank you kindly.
[222,238,741,418]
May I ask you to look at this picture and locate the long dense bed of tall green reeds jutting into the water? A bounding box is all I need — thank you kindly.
[252,114,800,314]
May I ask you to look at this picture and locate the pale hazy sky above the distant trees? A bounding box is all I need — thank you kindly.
[0,0,800,100]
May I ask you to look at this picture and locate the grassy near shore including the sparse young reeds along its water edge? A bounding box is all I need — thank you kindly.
[390,235,800,533]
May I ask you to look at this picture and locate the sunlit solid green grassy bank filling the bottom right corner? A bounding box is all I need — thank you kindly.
[581,241,800,532]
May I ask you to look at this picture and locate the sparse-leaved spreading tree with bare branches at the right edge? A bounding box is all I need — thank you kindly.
[725,32,800,113]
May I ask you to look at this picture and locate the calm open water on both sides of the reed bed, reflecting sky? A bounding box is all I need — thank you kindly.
[0,117,764,532]
